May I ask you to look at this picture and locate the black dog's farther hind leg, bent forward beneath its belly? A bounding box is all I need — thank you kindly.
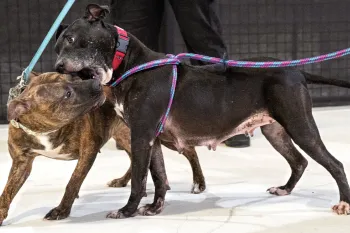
[261,122,308,196]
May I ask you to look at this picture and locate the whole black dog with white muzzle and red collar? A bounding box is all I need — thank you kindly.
[56,4,350,218]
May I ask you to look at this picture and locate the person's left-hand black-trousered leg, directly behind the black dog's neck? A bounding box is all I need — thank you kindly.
[110,0,164,51]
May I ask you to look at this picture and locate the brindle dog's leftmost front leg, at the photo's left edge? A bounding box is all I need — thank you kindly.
[0,155,34,226]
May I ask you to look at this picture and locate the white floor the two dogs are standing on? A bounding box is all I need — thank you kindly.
[0,107,350,233]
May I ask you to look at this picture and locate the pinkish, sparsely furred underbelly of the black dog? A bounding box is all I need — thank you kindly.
[166,111,275,153]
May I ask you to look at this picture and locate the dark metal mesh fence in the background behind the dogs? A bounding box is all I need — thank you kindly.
[0,0,350,123]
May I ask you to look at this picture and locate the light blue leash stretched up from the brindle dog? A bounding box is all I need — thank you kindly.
[22,0,75,84]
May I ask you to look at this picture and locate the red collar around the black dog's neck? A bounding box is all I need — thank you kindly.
[112,26,129,70]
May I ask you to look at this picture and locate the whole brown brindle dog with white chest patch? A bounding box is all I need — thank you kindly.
[0,72,205,226]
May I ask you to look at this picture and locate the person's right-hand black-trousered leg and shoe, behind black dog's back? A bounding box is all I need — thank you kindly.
[169,0,250,147]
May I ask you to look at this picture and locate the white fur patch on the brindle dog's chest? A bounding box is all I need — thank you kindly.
[32,136,74,160]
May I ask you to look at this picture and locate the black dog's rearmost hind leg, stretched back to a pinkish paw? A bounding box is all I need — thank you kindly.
[266,83,350,214]
